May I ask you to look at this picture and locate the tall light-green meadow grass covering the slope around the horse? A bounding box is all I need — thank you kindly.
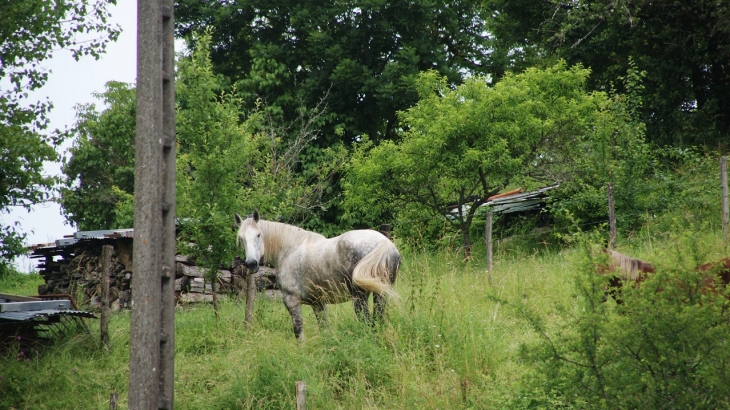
[0,229,726,409]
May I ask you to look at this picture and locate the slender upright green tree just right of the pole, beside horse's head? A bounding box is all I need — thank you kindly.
[176,37,264,281]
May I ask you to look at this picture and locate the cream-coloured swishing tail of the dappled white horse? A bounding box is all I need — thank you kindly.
[352,240,400,296]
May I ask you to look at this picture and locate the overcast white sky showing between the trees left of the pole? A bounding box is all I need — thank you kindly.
[0,0,137,272]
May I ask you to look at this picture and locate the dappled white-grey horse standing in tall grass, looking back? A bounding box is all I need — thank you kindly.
[236,211,400,340]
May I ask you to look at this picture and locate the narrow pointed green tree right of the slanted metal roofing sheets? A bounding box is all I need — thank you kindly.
[550,60,664,237]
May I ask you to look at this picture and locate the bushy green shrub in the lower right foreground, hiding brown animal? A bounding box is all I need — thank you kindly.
[519,234,730,409]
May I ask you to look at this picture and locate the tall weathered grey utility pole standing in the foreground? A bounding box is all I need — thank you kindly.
[129,0,175,409]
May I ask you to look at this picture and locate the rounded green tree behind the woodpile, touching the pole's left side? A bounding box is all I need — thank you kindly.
[61,81,136,230]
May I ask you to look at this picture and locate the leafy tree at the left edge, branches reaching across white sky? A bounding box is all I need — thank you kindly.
[0,0,119,263]
